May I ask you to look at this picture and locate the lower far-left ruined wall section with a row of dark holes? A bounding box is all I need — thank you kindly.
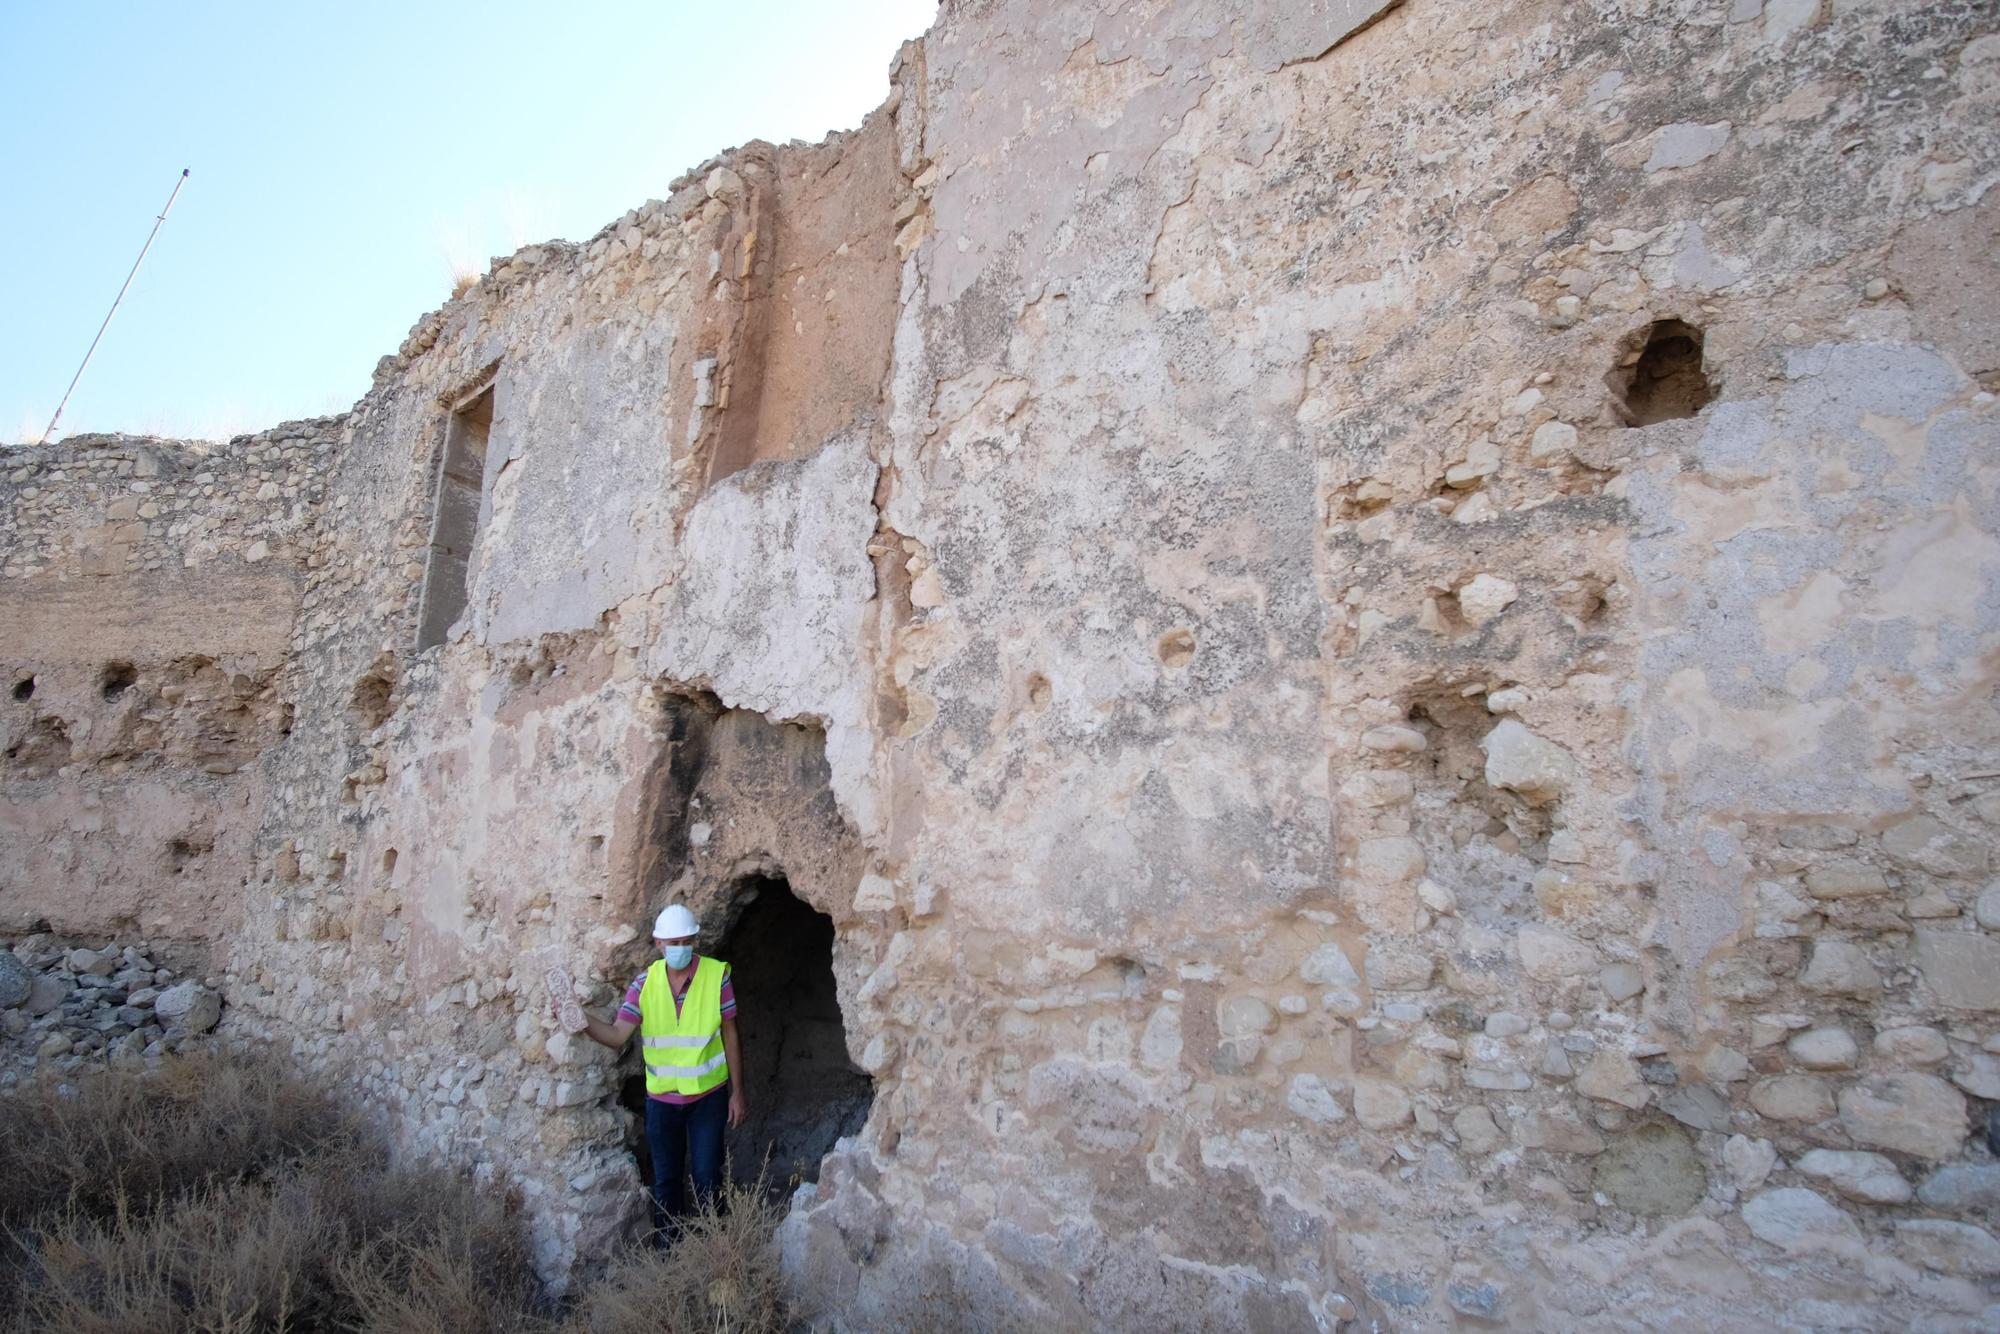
[0,422,338,954]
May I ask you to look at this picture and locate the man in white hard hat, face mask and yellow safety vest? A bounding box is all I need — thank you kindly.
[568,904,750,1242]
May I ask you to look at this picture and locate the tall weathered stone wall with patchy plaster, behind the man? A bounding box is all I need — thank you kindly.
[6,0,2000,1328]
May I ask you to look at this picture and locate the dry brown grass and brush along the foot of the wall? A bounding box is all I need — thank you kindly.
[0,1056,788,1334]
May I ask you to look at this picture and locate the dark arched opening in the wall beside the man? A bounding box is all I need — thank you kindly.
[716,876,874,1198]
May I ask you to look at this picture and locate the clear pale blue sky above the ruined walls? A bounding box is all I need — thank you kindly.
[0,0,936,444]
